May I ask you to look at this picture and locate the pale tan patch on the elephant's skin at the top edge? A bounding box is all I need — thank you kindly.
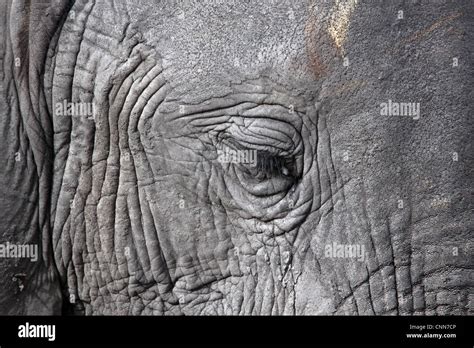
[328,0,359,56]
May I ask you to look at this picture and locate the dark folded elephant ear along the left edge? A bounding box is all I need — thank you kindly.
[0,0,71,315]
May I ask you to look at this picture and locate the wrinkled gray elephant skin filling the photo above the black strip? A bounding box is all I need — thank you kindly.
[0,0,474,315]
